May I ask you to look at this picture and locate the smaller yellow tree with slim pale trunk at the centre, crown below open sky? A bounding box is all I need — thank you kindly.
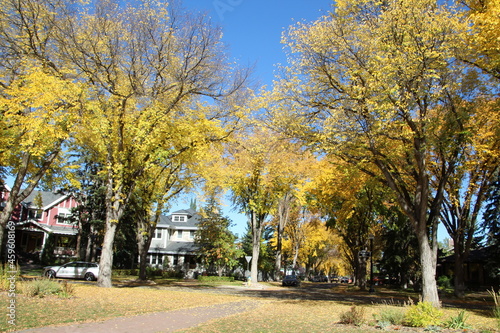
[220,123,308,282]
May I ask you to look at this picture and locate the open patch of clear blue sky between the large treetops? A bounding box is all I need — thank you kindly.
[182,0,334,85]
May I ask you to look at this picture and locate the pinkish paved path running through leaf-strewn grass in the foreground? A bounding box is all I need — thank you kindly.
[18,300,262,333]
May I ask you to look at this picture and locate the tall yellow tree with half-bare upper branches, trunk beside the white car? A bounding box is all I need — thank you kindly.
[58,0,250,287]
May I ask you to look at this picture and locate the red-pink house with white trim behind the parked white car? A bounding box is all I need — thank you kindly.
[2,188,78,257]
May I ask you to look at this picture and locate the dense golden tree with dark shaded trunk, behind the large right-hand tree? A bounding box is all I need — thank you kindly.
[303,158,389,289]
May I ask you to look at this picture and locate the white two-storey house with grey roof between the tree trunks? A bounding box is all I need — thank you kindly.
[147,209,201,274]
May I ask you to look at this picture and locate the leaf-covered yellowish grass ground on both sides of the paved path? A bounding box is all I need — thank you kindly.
[0,270,500,333]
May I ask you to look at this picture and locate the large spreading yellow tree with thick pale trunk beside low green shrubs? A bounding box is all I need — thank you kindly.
[274,0,477,307]
